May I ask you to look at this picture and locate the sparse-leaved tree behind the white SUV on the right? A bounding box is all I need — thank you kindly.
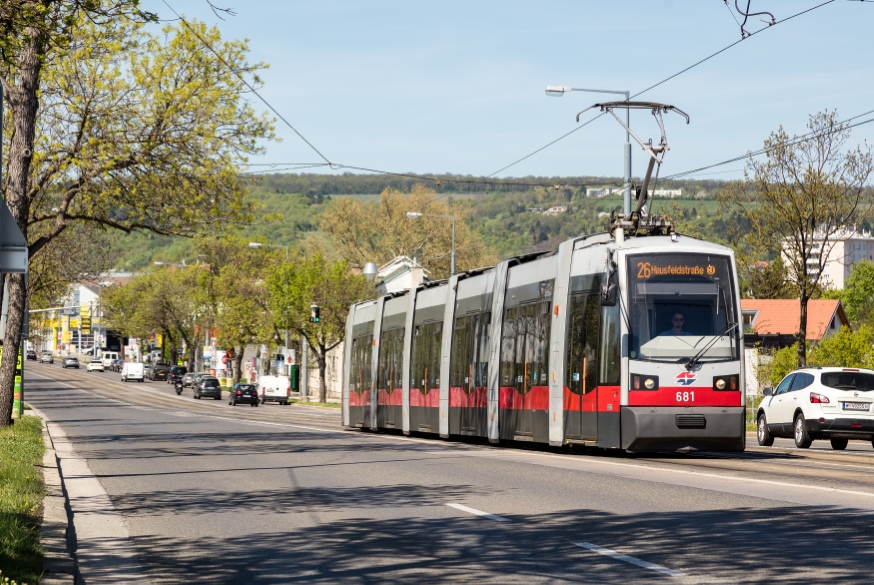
[720,112,874,366]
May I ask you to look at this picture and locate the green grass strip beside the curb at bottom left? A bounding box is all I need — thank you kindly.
[0,416,45,583]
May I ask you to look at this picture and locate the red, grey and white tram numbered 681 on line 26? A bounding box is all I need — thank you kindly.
[342,102,746,451]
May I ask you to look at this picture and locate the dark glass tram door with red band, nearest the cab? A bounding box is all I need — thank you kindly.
[565,293,601,439]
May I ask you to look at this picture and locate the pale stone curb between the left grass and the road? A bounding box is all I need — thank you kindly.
[30,405,78,585]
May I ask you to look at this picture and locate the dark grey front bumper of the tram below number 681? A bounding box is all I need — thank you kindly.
[621,406,746,451]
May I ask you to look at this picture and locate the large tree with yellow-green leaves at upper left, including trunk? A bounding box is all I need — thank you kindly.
[0,12,272,425]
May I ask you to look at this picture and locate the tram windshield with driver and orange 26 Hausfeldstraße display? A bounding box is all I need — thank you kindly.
[628,253,740,362]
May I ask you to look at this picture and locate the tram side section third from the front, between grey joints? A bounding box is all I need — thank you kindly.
[449,270,495,437]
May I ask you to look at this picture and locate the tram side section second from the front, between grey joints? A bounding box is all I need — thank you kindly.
[498,255,556,443]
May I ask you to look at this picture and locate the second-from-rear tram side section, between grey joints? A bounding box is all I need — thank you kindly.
[376,293,410,429]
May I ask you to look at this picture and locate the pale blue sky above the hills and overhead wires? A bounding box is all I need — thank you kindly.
[143,0,874,179]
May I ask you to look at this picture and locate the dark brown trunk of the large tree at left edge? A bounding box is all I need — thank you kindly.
[0,28,45,426]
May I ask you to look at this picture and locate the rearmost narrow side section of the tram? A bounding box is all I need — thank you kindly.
[348,301,377,428]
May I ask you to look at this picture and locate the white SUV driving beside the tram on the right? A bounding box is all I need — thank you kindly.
[756,367,874,450]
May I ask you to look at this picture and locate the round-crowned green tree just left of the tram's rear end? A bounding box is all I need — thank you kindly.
[269,253,374,402]
